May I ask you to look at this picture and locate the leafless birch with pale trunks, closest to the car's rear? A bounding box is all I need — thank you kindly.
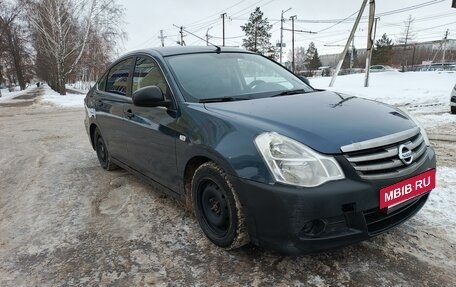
[29,0,123,95]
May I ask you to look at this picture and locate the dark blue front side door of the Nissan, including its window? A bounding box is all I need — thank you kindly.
[125,56,179,190]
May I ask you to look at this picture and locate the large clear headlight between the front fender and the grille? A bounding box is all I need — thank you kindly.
[255,132,345,187]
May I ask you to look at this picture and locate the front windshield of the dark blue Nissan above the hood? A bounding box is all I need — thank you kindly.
[167,53,313,102]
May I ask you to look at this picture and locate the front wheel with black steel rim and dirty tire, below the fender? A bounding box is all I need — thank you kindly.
[191,162,250,250]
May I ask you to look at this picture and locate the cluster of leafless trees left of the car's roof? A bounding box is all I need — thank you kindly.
[0,0,125,95]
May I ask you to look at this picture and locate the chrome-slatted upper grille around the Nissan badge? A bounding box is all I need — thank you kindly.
[341,128,427,180]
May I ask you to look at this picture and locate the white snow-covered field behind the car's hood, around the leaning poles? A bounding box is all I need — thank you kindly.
[309,71,456,106]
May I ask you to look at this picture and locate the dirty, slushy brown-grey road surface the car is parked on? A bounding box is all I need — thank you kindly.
[0,90,456,286]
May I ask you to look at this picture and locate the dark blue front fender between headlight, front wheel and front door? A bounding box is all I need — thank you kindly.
[176,106,273,186]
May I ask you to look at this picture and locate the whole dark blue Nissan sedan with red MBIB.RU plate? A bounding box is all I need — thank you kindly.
[85,47,436,254]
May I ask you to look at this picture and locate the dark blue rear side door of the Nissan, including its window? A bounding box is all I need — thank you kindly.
[95,57,134,163]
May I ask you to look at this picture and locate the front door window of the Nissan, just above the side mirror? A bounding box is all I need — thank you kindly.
[132,57,169,97]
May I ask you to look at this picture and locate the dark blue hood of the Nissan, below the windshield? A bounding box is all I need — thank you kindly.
[205,91,416,154]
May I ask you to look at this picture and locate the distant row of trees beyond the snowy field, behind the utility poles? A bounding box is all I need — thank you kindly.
[241,7,455,76]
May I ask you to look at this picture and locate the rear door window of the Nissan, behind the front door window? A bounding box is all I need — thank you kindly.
[105,59,133,96]
